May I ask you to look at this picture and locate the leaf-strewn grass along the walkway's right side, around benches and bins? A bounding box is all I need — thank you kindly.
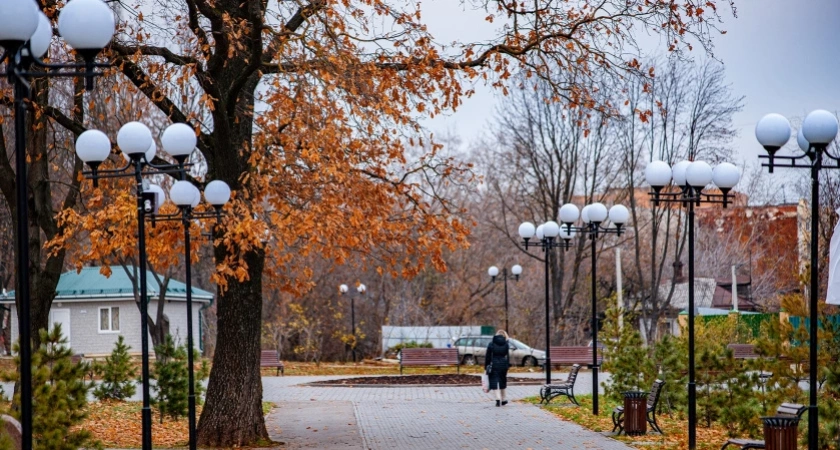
[524,395,740,450]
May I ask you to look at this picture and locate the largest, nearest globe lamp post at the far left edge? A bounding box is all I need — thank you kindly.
[0,0,116,450]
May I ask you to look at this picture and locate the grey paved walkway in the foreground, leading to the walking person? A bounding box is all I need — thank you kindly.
[263,373,630,450]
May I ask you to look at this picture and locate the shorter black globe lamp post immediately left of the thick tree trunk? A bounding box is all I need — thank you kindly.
[145,173,230,450]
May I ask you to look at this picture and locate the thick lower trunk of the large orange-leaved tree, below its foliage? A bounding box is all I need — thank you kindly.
[198,250,268,447]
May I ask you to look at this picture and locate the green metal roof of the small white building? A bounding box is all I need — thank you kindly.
[8,266,213,300]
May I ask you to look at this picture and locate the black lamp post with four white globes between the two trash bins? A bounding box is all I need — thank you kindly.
[645,161,741,450]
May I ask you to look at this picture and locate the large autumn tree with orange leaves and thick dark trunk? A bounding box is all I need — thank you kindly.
[26,0,731,446]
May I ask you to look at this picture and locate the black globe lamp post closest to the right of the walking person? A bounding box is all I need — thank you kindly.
[519,220,575,385]
